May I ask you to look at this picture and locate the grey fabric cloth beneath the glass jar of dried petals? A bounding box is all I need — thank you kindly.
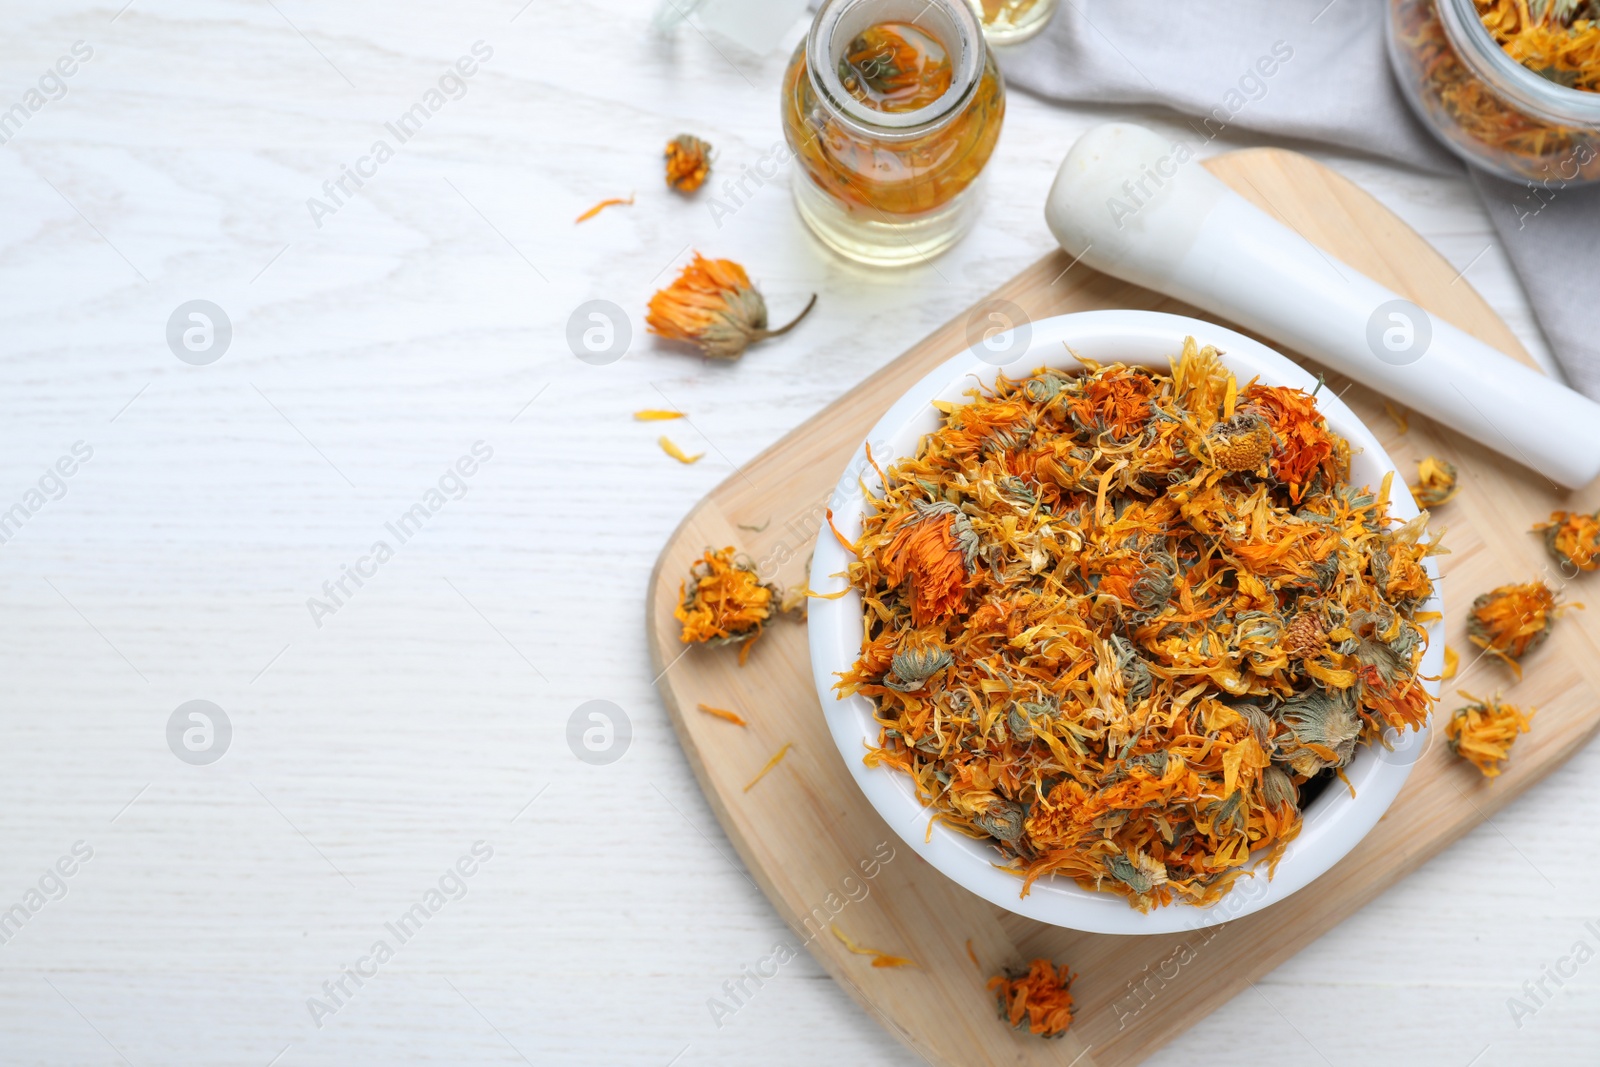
[1002,0,1600,400]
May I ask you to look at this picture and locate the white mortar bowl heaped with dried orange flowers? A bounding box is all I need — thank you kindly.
[808,310,1443,934]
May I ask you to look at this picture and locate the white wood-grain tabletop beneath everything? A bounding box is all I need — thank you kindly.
[0,0,1600,1067]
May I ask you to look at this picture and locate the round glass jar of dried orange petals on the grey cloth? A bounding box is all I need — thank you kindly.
[1389,0,1600,183]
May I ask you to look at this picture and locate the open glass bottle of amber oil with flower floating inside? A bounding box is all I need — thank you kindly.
[782,0,1005,266]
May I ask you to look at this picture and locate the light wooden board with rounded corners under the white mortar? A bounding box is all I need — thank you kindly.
[646,149,1600,1067]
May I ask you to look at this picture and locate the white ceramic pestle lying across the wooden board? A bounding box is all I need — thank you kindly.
[1045,123,1600,490]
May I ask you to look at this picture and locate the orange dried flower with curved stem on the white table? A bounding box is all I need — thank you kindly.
[645,253,816,360]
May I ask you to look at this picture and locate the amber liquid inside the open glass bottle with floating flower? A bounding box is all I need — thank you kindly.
[782,22,1005,219]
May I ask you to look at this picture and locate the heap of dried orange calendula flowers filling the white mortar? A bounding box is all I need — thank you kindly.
[834,339,1438,910]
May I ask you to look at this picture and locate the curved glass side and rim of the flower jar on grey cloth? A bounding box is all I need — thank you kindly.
[1389,0,1600,186]
